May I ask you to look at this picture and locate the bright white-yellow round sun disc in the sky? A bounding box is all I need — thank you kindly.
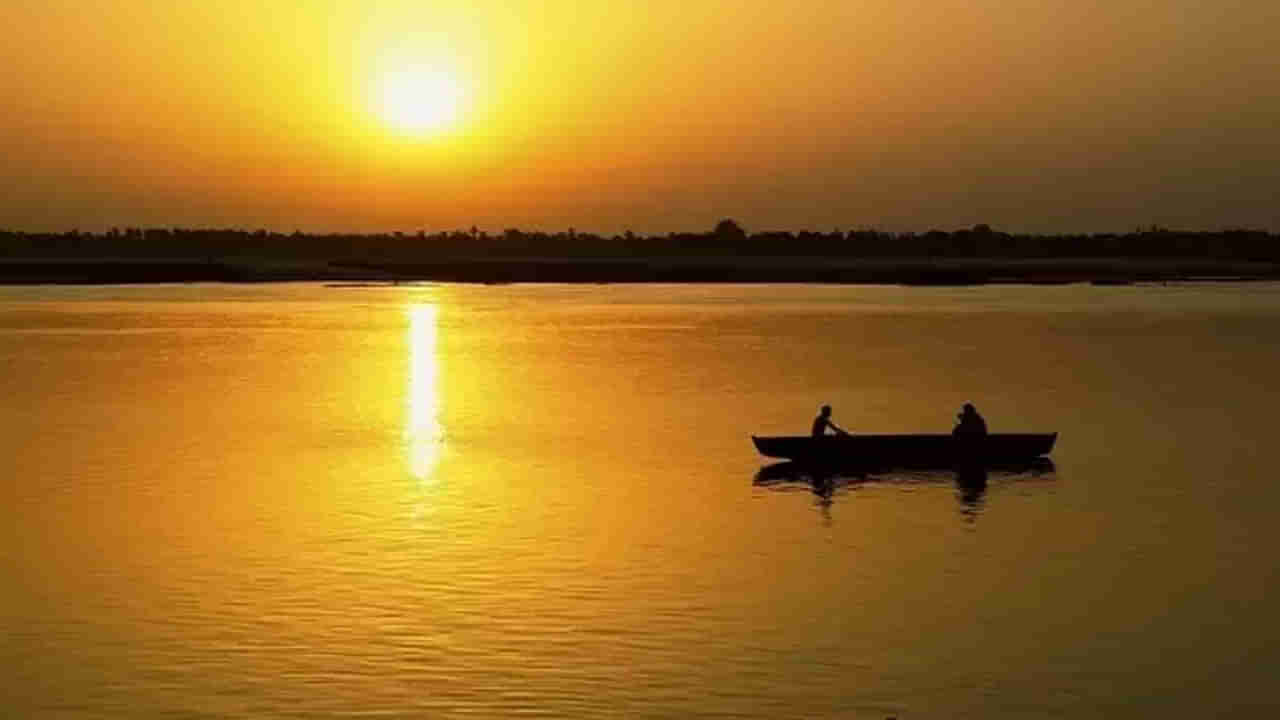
[378,64,465,136]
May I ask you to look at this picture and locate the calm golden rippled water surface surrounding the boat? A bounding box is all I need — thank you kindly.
[0,284,1280,719]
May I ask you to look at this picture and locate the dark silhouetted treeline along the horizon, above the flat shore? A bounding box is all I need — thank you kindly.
[0,220,1280,263]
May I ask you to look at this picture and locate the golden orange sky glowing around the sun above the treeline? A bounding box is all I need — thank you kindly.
[0,0,1280,233]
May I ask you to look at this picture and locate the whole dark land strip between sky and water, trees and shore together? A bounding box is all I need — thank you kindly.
[0,220,1280,286]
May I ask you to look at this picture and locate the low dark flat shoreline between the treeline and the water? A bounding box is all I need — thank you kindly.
[0,256,1280,286]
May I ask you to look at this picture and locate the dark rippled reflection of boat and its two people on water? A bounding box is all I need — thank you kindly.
[753,457,1057,523]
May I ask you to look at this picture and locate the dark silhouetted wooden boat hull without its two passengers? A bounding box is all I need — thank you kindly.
[751,433,1057,468]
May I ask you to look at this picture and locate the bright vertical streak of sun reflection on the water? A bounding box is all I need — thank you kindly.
[406,299,444,480]
